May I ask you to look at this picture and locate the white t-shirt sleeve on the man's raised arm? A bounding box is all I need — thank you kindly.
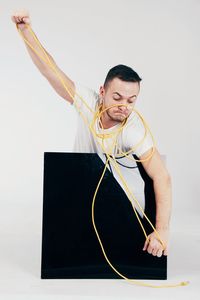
[72,82,98,114]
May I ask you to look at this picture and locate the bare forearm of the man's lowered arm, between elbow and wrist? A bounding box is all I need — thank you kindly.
[153,176,172,230]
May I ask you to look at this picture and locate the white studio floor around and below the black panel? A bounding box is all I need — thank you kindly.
[0,200,200,300]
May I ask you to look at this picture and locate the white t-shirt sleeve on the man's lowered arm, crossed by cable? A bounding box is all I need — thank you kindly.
[124,115,154,158]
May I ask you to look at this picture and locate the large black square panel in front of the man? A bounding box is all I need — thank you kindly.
[41,152,167,279]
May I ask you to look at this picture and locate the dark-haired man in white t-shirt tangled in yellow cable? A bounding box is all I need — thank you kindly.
[12,11,171,257]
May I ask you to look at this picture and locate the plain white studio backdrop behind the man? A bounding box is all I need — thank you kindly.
[0,0,200,298]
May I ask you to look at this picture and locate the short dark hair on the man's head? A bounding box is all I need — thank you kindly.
[104,65,142,88]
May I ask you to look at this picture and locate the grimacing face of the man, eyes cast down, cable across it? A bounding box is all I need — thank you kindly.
[100,78,140,122]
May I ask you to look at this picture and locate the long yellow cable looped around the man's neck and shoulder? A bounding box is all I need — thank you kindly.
[16,24,188,288]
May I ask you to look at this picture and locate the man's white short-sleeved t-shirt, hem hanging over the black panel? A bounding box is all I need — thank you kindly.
[72,83,153,217]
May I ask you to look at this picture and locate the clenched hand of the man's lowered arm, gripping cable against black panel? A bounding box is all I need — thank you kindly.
[143,230,169,257]
